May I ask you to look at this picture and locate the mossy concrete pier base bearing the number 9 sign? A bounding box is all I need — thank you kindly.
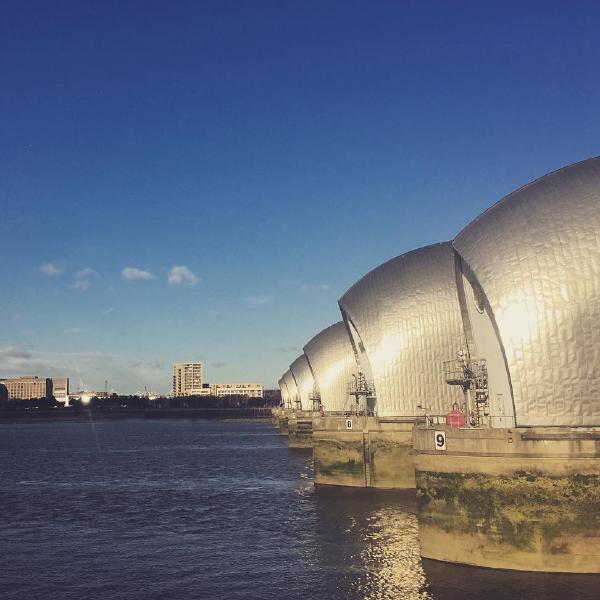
[413,425,600,573]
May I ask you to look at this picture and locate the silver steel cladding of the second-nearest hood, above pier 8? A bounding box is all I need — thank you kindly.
[339,242,465,416]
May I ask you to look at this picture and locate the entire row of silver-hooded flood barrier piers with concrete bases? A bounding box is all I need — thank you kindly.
[273,158,600,573]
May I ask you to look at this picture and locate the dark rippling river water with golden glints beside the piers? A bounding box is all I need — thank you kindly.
[0,420,600,600]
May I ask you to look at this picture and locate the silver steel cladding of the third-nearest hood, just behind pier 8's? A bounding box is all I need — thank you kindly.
[304,321,356,411]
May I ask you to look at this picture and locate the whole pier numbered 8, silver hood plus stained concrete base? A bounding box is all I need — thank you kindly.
[313,242,464,489]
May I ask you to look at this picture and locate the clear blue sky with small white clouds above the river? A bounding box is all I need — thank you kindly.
[0,1,600,392]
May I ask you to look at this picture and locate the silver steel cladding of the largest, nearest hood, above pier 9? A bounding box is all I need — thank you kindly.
[454,158,600,426]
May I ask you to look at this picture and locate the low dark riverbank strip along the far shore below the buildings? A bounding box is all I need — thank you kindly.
[0,407,271,423]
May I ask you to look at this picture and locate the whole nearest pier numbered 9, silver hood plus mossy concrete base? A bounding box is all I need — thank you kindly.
[414,158,600,573]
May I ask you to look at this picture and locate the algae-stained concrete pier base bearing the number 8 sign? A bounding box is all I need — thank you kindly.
[313,416,415,489]
